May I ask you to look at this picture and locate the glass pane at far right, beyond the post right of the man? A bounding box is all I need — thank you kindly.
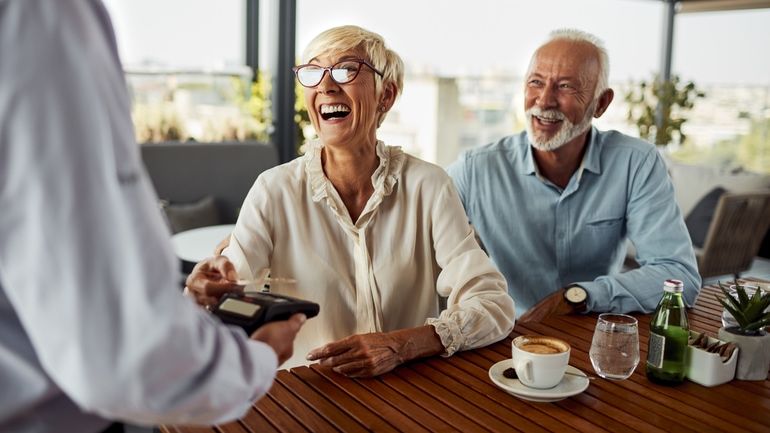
[672,9,770,173]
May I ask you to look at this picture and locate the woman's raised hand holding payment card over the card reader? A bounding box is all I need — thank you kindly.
[185,256,238,307]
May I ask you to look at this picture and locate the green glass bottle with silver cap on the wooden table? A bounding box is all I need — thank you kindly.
[647,280,690,385]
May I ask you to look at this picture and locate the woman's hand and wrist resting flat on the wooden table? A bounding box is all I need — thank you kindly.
[307,326,444,377]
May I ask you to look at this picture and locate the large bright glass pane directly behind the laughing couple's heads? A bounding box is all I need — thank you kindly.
[297,0,663,166]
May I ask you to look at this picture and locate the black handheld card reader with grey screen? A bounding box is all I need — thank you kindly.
[211,292,320,335]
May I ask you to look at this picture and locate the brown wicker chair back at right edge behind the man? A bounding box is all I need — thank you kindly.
[695,191,770,278]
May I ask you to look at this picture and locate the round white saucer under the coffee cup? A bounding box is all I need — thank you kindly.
[489,359,589,402]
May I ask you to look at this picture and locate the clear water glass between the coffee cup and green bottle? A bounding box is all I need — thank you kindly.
[589,313,639,380]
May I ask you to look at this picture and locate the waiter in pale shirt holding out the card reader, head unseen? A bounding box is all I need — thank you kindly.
[0,0,304,432]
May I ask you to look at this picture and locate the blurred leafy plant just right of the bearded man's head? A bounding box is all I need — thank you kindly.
[624,74,705,145]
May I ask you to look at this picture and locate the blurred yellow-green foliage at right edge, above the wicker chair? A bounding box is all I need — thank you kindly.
[670,119,770,173]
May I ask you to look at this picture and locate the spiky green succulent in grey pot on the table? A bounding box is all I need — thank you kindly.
[716,281,770,380]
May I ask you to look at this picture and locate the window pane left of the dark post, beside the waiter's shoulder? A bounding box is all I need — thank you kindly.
[105,0,260,143]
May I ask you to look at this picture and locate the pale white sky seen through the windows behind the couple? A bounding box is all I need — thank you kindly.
[105,0,770,85]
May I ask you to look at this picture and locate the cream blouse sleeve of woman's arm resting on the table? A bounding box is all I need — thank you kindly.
[425,178,515,356]
